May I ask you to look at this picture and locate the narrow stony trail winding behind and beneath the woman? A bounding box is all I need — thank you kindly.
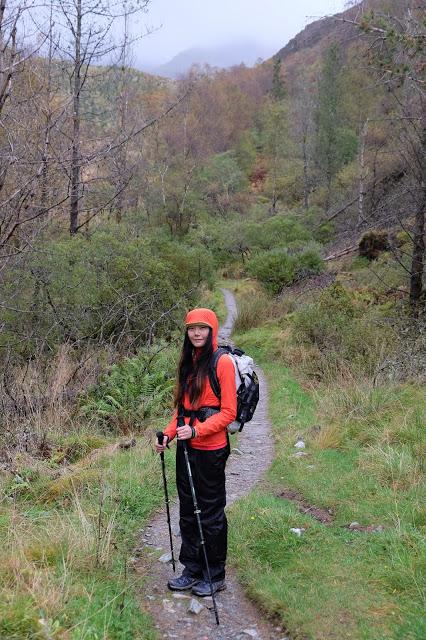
[135,289,286,640]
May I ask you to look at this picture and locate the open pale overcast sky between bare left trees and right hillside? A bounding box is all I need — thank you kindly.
[134,0,346,64]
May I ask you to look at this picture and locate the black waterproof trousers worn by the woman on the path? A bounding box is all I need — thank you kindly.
[176,443,229,582]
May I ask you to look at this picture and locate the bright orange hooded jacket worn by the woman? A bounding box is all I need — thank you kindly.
[164,309,237,450]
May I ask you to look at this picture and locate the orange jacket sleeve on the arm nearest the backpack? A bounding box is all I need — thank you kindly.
[196,354,237,437]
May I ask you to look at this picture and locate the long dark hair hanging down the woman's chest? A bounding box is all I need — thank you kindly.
[175,328,213,407]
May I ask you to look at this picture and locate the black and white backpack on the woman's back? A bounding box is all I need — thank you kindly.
[209,345,259,433]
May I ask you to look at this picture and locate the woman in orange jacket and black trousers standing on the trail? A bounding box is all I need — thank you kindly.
[156,309,237,596]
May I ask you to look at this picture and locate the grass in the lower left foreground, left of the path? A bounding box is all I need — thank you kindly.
[0,439,173,640]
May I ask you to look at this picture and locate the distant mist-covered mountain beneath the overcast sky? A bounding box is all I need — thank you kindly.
[141,41,271,78]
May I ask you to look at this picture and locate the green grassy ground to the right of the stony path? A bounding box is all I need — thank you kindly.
[230,321,426,640]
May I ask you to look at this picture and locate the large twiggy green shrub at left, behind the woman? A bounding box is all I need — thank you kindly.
[0,225,213,357]
